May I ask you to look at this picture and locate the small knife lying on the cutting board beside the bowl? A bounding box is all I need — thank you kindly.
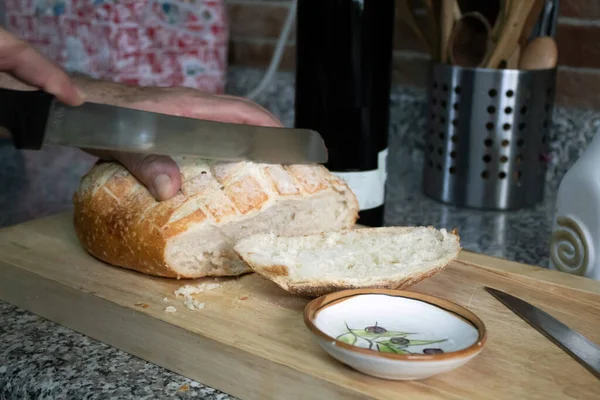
[485,286,600,379]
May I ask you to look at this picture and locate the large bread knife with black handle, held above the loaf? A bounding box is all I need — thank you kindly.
[0,89,327,164]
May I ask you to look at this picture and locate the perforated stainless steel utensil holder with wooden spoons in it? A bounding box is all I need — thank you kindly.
[423,64,556,210]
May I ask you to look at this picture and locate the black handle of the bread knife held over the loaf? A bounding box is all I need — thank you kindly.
[0,88,54,150]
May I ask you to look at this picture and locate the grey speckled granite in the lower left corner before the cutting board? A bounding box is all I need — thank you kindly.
[0,303,239,400]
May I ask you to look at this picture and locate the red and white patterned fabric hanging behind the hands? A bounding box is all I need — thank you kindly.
[4,0,228,93]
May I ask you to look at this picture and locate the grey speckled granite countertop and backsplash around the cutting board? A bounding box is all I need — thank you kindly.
[0,69,598,399]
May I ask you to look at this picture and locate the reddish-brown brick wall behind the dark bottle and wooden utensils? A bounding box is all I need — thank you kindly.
[225,0,600,109]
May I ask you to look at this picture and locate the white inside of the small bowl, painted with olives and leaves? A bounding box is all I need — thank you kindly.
[314,294,478,354]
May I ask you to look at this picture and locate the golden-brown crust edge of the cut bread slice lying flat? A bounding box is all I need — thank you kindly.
[234,226,462,298]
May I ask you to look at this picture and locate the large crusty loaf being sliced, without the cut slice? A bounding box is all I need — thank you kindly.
[73,157,358,278]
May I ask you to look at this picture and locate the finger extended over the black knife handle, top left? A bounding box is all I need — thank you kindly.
[0,29,85,106]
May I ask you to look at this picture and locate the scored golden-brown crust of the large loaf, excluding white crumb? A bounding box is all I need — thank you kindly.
[73,157,358,278]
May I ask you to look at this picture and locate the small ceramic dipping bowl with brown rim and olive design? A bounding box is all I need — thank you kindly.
[304,289,487,380]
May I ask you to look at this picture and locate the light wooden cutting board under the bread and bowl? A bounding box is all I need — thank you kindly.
[0,213,600,400]
